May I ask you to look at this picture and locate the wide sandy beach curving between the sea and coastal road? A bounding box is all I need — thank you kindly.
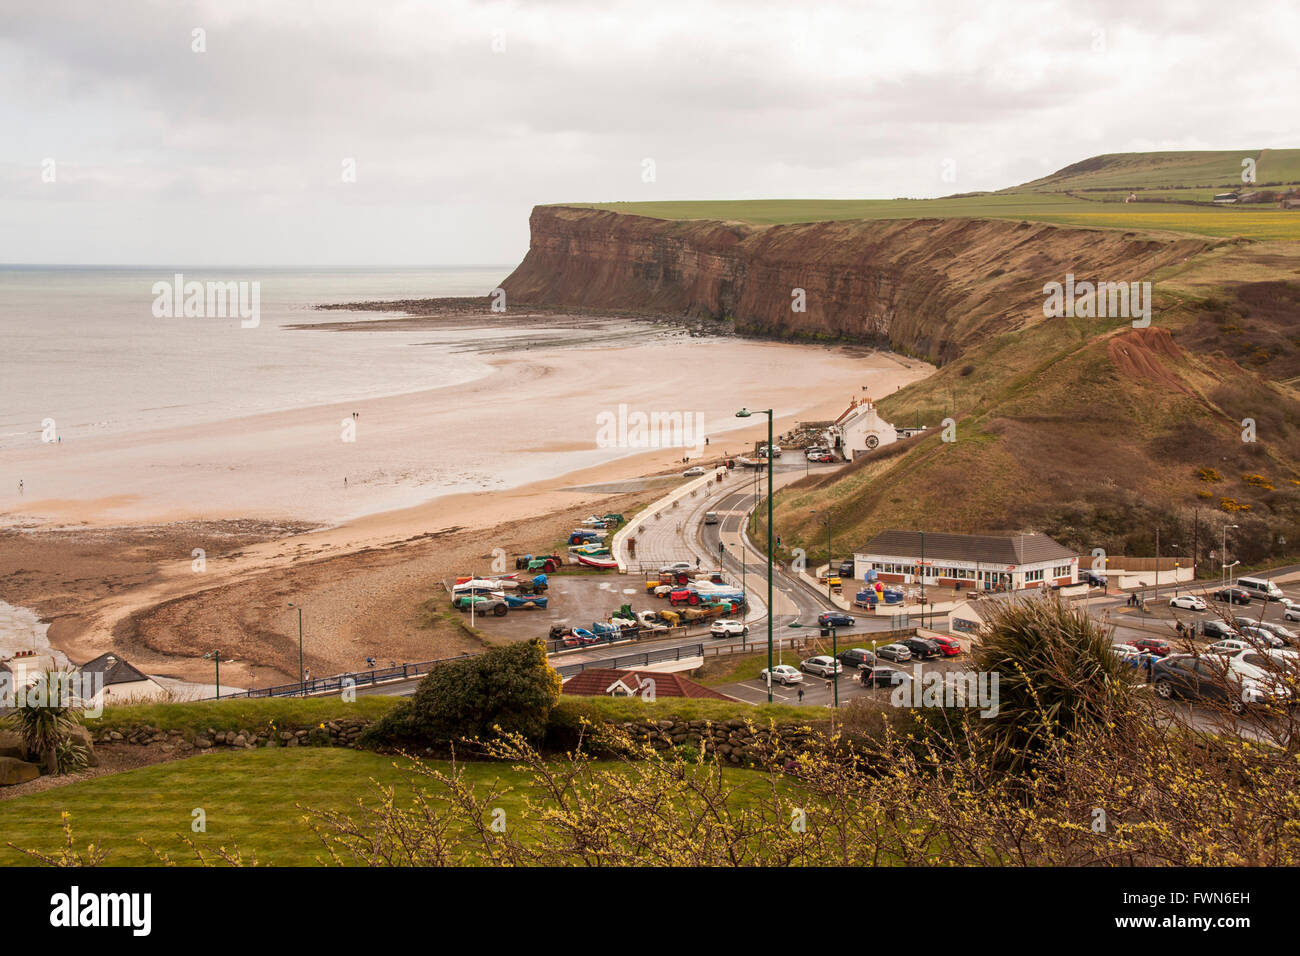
[0,310,932,685]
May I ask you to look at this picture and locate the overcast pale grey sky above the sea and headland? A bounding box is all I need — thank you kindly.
[0,0,1300,265]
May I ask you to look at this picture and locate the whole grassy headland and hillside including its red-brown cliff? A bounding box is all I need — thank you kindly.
[504,150,1300,563]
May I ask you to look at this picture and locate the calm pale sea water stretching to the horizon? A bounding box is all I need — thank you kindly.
[0,265,512,447]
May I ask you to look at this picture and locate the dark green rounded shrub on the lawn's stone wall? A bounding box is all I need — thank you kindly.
[361,640,560,749]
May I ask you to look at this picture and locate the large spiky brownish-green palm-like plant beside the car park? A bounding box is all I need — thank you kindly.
[972,596,1135,767]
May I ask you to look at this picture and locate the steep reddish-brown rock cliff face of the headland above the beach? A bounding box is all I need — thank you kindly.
[503,206,1210,363]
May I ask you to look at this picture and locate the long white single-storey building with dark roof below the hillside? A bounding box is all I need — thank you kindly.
[853,531,1079,591]
